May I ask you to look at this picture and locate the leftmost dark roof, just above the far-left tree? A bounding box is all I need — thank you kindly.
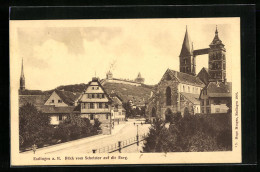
[19,95,50,107]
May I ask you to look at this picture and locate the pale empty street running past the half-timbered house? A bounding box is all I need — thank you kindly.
[24,119,150,155]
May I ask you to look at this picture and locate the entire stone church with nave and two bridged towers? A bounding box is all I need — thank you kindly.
[146,27,231,120]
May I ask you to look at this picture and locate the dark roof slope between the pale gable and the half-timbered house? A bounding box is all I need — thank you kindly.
[55,90,81,105]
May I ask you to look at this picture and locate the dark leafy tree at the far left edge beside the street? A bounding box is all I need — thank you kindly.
[19,103,53,148]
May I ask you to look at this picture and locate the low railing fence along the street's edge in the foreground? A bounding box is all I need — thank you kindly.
[92,134,147,153]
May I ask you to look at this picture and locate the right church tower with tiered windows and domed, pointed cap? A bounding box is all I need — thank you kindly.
[209,27,226,82]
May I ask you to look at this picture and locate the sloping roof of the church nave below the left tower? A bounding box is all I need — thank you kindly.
[169,69,205,87]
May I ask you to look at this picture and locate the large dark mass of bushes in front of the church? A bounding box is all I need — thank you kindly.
[144,113,232,152]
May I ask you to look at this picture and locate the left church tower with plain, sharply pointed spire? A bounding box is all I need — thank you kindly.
[179,26,196,75]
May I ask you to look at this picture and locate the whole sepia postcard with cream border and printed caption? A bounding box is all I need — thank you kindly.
[10,17,241,165]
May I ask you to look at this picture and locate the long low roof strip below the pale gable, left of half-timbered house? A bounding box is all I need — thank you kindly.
[37,105,76,114]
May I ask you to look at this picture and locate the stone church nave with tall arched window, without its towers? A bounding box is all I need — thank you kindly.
[147,69,205,120]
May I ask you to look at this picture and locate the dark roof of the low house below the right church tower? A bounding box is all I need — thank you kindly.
[206,82,232,97]
